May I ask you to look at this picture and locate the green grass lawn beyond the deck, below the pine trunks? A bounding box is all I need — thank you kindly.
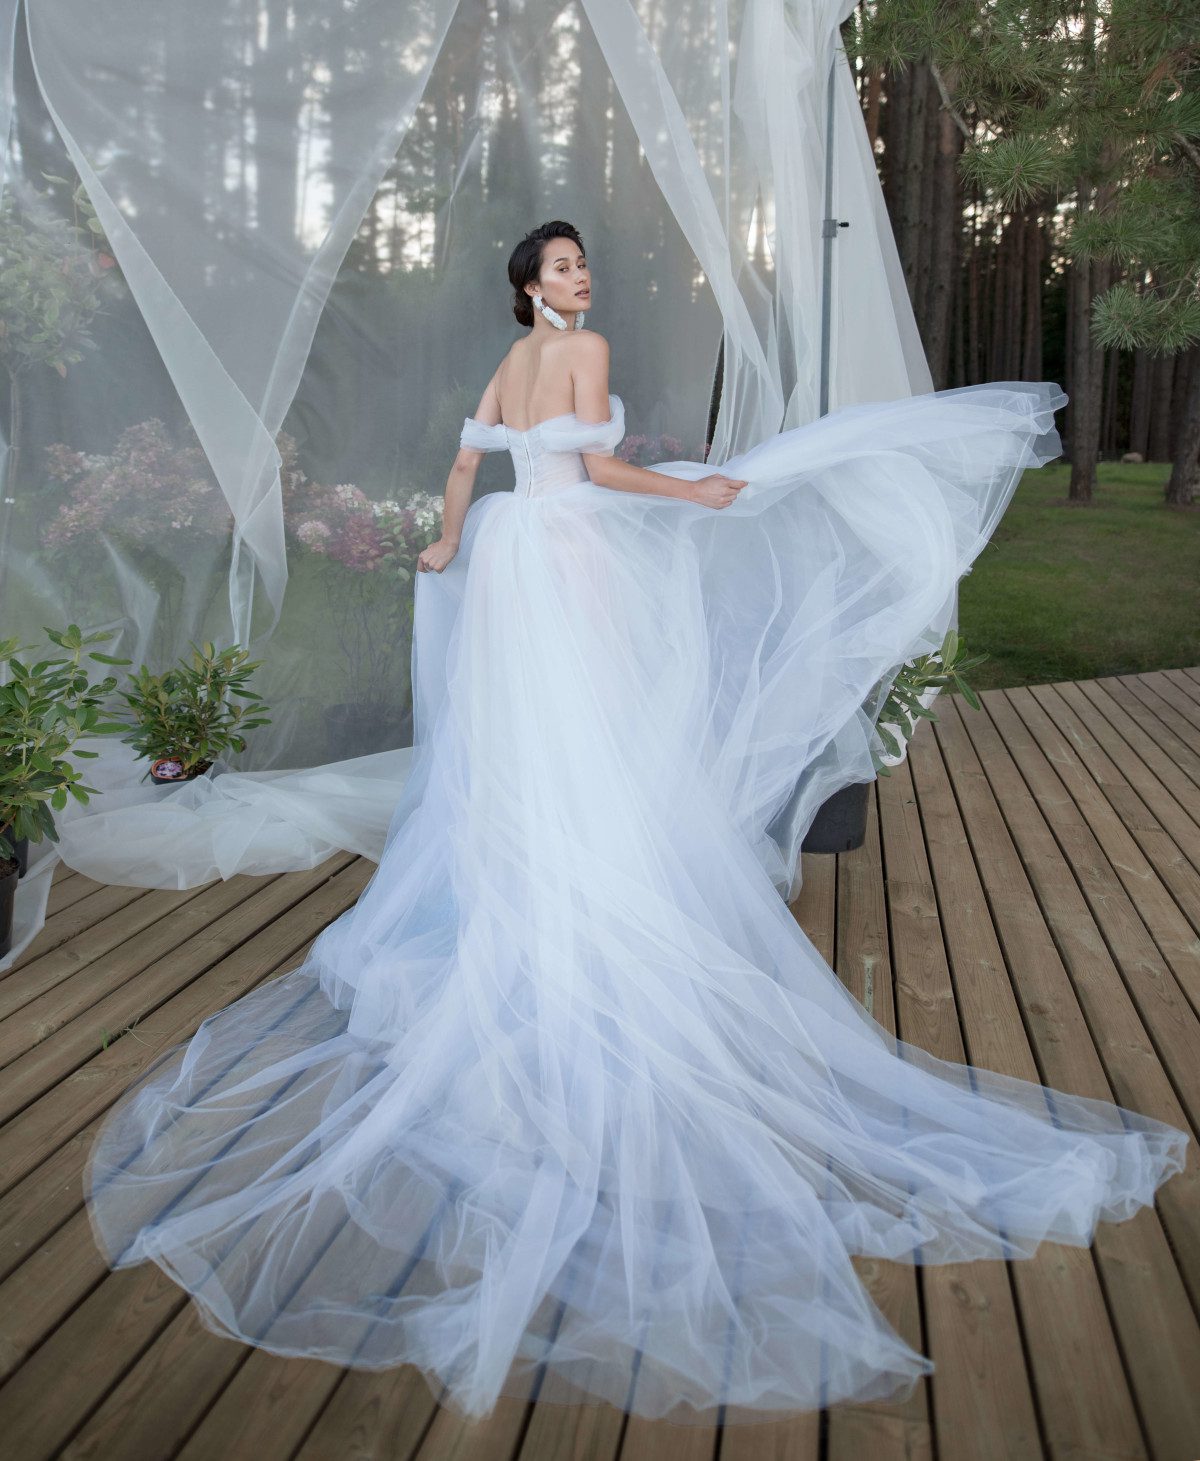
[959,462,1200,690]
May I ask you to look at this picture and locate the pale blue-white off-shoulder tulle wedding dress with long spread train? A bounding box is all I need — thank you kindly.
[86,383,1188,1423]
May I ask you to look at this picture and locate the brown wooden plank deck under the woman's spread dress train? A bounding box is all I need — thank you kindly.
[0,669,1200,1461]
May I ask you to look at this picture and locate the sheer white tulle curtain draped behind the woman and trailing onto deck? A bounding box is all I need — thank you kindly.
[0,0,930,970]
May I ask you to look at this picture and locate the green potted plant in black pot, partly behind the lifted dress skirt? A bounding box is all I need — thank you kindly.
[801,628,988,852]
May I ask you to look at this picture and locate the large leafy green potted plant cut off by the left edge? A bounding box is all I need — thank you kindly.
[0,624,129,954]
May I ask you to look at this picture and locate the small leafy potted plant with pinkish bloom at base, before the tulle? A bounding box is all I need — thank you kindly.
[118,643,270,785]
